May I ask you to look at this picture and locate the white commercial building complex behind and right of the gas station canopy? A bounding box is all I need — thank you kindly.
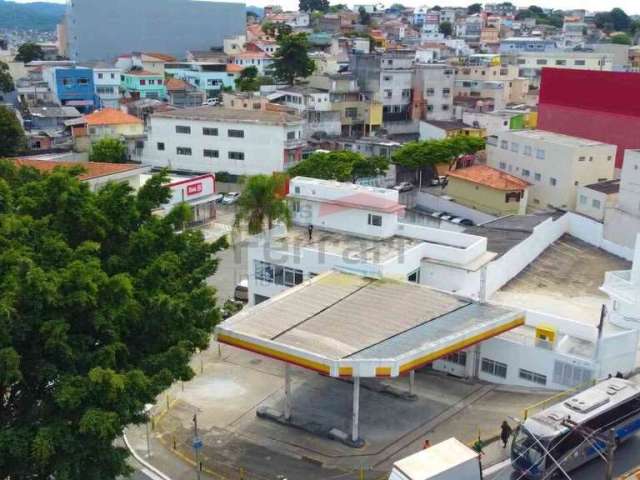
[241,177,638,389]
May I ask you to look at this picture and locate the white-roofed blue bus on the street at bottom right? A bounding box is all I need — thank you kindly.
[511,378,640,479]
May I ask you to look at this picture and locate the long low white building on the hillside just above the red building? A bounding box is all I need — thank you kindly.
[516,50,613,87]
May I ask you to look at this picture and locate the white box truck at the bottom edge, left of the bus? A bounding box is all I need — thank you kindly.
[389,438,482,480]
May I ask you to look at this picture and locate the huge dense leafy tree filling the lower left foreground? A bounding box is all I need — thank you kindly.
[0,161,226,480]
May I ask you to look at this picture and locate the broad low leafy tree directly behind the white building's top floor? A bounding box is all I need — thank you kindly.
[288,151,389,182]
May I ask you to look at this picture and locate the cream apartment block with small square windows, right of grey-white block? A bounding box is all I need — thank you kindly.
[412,63,455,121]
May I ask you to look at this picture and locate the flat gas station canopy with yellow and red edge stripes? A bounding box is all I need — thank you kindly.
[216,271,524,377]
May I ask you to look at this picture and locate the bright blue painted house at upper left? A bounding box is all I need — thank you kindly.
[42,66,98,113]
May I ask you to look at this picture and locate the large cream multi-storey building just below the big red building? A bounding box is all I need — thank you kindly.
[487,130,616,209]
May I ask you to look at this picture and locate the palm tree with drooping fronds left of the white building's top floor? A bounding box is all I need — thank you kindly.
[234,175,291,235]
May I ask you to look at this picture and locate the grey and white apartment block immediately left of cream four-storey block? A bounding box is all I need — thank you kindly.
[349,50,415,124]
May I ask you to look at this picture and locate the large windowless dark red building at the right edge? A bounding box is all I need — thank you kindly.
[538,68,640,169]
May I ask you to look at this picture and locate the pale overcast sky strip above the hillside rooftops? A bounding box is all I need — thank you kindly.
[15,0,640,15]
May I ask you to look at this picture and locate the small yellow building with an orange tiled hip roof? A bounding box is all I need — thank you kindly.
[446,165,529,216]
